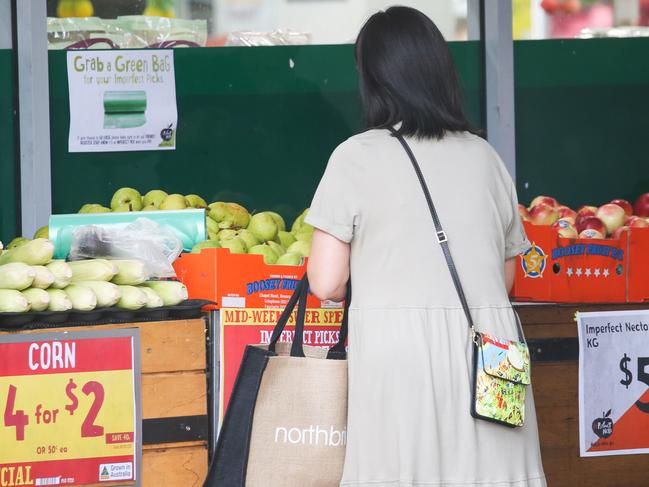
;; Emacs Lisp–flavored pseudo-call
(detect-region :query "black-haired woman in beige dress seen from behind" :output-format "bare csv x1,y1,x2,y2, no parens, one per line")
306,7,546,487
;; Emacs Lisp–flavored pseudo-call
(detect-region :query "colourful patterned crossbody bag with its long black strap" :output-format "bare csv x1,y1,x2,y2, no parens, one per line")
389,127,530,427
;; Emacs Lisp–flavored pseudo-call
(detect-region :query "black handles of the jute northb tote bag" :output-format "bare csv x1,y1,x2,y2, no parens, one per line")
268,274,351,360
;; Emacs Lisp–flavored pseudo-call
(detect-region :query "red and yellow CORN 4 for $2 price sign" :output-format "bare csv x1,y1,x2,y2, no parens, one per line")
0,329,141,487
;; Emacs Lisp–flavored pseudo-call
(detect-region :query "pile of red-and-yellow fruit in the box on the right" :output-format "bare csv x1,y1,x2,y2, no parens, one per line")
518,193,649,238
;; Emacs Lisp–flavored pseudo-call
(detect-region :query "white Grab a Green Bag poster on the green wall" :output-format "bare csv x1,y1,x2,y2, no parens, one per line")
67,49,178,152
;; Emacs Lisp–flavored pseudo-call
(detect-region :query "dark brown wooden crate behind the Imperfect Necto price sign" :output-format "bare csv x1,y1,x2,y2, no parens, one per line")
517,304,649,487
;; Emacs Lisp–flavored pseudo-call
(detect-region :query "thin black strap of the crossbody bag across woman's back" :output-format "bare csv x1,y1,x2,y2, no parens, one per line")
388,127,525,341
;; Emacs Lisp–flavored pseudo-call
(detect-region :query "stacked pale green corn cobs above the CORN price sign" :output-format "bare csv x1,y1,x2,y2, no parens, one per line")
0,238,187,313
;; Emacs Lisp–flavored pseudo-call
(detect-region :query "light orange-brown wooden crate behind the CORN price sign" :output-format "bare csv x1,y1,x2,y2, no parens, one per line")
0,319,208,487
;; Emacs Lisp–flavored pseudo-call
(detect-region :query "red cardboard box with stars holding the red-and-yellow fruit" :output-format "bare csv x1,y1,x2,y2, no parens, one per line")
512,222,649,303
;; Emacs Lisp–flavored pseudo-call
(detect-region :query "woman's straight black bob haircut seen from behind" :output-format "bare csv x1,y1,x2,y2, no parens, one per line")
355,7,471,139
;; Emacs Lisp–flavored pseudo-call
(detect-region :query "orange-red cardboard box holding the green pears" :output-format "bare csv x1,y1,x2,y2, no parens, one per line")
174,248,326,308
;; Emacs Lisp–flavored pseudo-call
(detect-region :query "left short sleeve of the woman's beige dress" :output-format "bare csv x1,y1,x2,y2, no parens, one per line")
304,143,359,243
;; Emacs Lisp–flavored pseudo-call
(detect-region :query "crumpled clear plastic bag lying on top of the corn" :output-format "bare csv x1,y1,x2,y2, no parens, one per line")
69,218,183,277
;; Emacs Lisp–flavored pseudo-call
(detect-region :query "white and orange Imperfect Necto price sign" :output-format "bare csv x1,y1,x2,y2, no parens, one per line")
577,310,649,456
